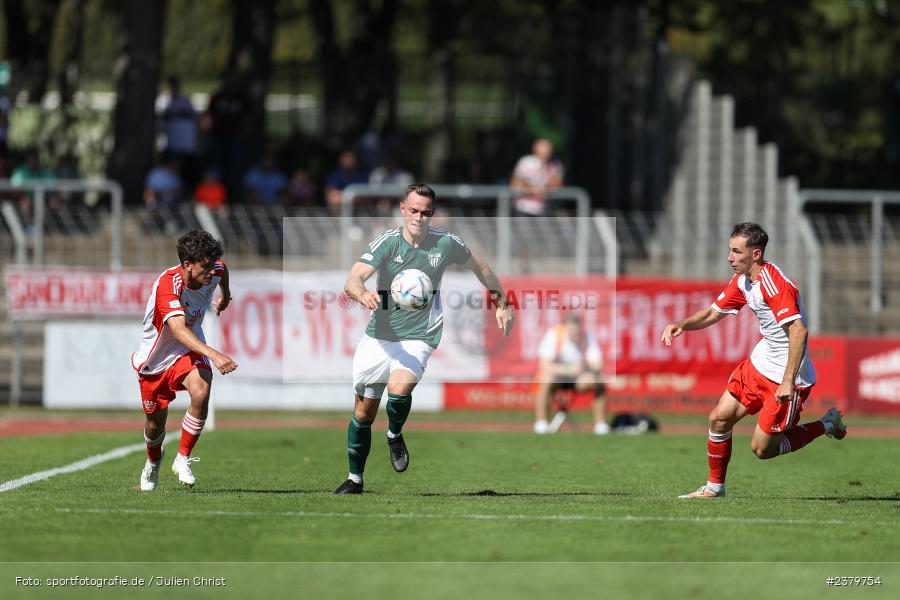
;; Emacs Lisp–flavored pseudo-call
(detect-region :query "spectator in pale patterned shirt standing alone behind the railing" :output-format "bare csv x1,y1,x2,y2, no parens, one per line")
509,138,563,216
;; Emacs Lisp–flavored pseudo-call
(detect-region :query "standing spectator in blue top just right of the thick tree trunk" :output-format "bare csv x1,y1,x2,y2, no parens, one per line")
156,75,199,190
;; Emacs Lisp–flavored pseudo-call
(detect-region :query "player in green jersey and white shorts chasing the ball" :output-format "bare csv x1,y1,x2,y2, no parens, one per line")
334,183,513,494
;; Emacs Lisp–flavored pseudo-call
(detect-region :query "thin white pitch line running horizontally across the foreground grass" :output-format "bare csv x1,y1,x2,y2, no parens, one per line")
47,508,900,527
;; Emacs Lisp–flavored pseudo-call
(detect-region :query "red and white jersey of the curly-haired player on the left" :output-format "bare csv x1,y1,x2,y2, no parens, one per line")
131,260,225,375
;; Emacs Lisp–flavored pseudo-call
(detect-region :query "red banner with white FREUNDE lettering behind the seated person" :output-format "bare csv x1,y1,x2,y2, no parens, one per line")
485,276,760,381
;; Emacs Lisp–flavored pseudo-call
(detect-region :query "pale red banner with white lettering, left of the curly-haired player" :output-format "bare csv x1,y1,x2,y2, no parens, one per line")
5,266,155,319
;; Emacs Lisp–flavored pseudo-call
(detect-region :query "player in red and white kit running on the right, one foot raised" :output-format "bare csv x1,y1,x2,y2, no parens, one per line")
662,223,847,498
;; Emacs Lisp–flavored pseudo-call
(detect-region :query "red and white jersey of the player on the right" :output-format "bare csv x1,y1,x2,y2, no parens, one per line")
712,261,816,387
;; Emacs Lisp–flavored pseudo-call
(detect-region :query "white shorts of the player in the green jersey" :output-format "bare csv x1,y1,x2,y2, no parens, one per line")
353,334,434,400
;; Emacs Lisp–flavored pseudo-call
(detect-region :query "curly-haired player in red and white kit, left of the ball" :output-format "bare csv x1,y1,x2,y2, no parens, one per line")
131,230,237,492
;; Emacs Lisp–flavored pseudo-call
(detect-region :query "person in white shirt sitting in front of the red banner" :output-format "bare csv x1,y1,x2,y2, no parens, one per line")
534,313,609,435
